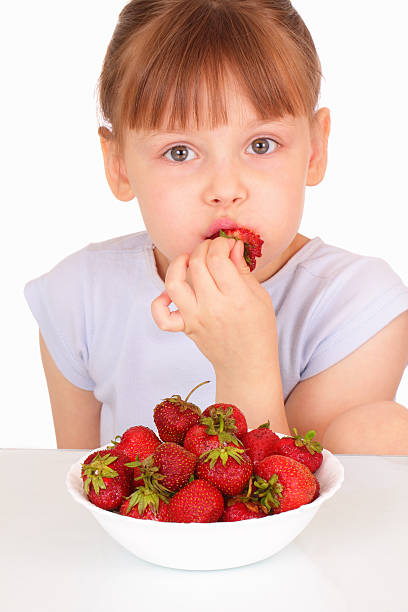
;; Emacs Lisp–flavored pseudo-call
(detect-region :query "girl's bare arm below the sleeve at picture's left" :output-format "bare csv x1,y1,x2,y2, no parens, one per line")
40,332,102,449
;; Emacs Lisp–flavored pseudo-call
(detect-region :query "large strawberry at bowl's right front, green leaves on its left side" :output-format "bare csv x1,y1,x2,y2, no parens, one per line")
254,455,316,514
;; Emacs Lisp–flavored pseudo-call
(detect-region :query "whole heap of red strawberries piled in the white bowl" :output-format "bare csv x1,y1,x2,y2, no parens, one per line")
81,381,323,523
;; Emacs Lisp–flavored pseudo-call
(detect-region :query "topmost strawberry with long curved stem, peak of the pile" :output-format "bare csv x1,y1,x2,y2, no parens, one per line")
153,380,210,444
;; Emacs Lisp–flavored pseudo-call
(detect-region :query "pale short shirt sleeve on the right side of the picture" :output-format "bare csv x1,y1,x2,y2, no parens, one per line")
300,257,408,380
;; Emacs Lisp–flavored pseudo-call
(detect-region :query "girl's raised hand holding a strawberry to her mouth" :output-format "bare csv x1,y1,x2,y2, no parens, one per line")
151,237,278,373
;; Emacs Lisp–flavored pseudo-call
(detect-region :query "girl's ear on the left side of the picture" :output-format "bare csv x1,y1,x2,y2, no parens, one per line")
98,127,135,202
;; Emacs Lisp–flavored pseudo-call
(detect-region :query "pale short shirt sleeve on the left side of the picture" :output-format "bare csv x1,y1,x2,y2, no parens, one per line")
24,249,95,391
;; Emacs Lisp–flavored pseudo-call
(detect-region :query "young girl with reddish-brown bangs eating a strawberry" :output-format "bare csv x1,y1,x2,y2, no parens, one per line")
25,0,408,454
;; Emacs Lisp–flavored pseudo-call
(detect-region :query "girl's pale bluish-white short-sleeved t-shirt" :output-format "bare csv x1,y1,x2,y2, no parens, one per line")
24,231,408,445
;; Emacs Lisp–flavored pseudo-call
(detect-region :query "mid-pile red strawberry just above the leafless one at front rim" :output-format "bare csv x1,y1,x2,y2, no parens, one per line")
153,442,197,491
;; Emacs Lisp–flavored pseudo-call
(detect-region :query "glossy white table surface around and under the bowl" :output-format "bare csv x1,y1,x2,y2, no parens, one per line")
0,449,408,612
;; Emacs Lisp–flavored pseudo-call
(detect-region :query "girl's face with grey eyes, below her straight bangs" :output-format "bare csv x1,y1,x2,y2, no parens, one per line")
110,79,330,282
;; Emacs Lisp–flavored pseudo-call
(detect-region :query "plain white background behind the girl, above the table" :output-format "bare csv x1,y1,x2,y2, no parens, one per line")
0,0,408,448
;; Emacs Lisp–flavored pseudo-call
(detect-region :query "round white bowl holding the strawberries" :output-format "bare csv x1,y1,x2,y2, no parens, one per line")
65,434,344,570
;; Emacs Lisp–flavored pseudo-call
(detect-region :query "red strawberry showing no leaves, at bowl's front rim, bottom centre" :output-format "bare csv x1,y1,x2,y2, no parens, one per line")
169,480,224,523
